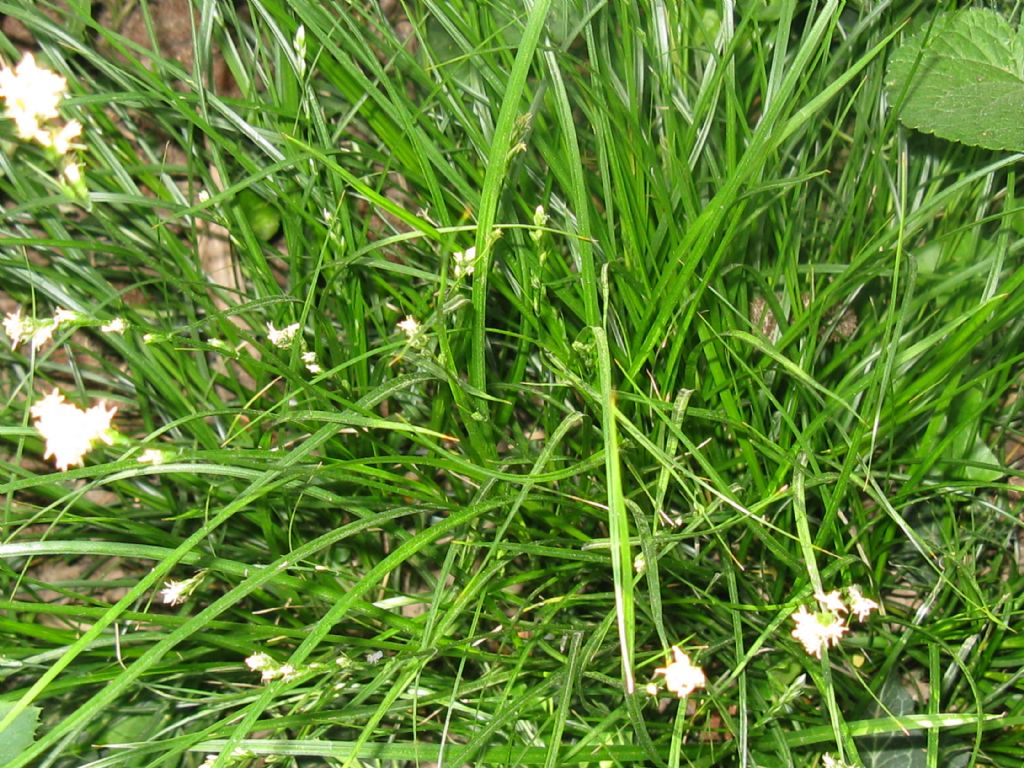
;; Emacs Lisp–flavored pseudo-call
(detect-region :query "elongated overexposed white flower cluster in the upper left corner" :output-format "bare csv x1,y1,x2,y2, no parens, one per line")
0,53,82,187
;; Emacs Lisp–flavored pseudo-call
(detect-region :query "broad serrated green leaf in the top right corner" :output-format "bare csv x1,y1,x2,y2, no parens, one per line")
886,8,1024,151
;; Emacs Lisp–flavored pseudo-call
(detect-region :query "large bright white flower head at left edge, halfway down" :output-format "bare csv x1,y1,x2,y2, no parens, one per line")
32,389,118,470
